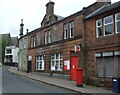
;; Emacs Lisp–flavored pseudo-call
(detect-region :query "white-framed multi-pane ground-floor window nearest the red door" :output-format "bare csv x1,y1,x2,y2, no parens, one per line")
51,53,63,71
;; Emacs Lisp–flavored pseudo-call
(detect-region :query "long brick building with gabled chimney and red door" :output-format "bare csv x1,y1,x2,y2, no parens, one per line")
28,1,109,80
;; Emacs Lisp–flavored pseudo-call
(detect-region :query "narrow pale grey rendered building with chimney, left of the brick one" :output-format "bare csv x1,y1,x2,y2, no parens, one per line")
18,19,28,72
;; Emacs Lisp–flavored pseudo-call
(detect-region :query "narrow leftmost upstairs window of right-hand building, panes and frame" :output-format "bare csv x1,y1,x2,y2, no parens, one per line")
96,19,102,38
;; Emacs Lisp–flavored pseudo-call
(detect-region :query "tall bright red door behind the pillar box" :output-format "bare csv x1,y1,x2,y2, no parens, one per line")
70,52,78,80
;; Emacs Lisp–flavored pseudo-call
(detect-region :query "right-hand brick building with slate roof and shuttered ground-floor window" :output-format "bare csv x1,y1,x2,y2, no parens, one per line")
85,2,120,88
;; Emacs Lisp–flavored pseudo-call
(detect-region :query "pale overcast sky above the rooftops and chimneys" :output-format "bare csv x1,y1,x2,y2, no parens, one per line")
0,0,119,37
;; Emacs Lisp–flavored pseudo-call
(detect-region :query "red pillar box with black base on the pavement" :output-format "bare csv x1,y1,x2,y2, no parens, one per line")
76,68,83,87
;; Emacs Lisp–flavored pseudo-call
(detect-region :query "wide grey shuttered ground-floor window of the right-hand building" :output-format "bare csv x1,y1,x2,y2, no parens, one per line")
95,52,116,78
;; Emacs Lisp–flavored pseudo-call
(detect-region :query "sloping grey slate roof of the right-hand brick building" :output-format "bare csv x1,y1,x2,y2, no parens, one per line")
86,1,120,19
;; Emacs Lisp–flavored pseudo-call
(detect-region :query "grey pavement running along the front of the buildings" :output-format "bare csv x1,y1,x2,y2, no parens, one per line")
9,67,120,95
